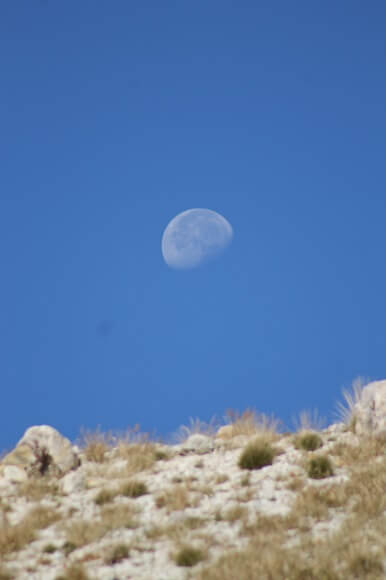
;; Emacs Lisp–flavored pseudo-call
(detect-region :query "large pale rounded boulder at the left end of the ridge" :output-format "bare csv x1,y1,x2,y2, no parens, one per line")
0,425,80,482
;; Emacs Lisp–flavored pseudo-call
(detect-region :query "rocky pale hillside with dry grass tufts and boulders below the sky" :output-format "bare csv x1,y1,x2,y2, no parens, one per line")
0,381,386,580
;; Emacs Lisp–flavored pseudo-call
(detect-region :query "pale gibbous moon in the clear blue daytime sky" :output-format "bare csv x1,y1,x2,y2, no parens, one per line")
162,209,233,270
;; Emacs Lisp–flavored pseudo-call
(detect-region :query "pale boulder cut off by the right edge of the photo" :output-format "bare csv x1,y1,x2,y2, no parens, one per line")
353,381,386,435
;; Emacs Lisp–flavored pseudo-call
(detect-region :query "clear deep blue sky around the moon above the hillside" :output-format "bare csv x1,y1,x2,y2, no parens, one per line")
0,0,386,449
